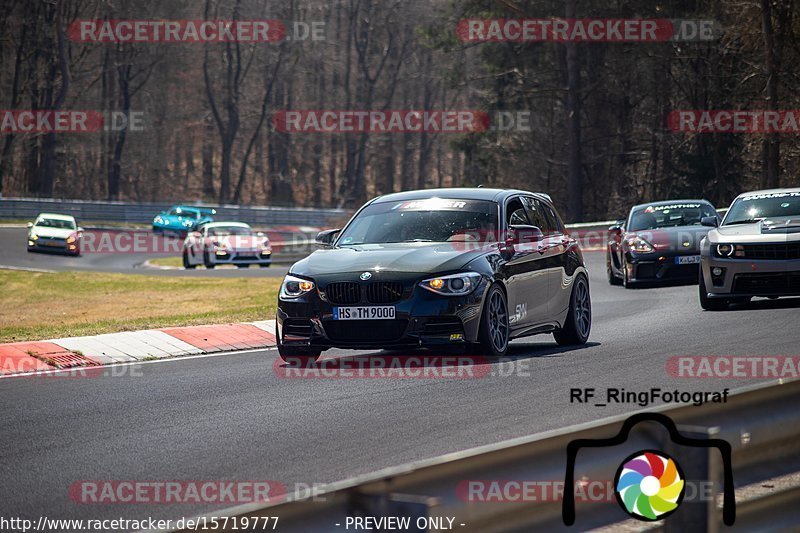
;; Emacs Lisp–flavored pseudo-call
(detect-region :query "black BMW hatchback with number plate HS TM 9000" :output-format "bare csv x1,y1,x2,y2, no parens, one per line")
277,188,592,360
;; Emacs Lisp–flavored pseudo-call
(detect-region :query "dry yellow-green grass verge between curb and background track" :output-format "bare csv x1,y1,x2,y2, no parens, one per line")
0,270,281,342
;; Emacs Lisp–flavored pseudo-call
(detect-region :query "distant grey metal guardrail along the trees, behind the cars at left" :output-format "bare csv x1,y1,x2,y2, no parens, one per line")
0,198,350,227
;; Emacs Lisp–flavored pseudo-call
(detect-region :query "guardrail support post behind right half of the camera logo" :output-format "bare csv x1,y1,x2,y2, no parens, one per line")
663,426,722,533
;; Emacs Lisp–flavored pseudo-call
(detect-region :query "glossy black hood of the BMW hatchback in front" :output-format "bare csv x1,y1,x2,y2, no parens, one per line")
290,242,497,277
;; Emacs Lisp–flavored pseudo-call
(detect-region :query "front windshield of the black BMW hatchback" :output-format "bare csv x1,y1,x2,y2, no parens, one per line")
337,198,498,246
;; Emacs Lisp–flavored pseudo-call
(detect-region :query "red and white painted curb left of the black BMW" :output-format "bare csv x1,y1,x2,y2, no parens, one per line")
0,320,275,376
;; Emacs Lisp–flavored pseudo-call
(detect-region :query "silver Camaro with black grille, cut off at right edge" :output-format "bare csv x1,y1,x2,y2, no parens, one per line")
700,188,800,311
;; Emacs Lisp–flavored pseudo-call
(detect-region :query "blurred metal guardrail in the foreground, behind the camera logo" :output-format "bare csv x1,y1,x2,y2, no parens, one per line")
169,381,800,532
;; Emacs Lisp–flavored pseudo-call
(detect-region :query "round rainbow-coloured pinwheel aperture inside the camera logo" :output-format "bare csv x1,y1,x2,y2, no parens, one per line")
614,450,685,521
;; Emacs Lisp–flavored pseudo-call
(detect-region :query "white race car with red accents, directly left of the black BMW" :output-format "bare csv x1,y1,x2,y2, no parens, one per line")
183,222,272,269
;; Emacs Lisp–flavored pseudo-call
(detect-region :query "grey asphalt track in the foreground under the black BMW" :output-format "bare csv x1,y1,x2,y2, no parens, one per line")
0,253,800,532
